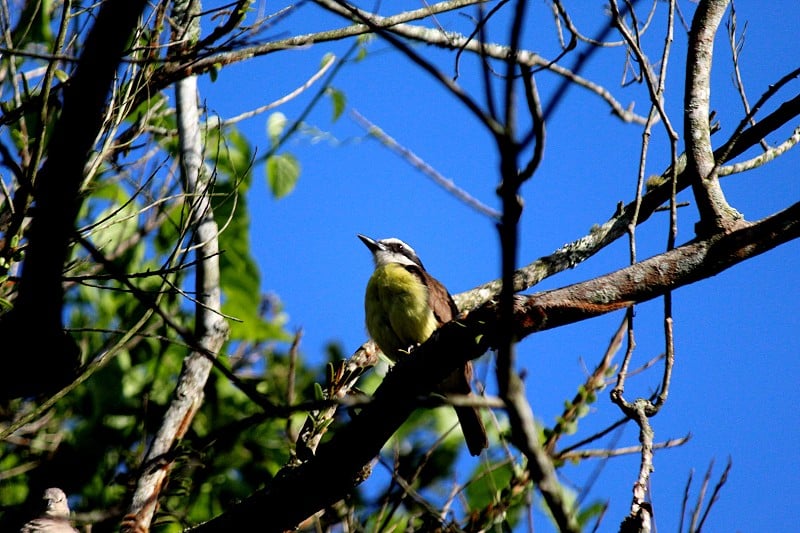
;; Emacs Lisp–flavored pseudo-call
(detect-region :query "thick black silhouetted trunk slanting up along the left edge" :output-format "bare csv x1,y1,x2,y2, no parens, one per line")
0,0,145,397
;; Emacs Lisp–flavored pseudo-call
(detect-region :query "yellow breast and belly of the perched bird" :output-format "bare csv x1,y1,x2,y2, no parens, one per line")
364,263,437,360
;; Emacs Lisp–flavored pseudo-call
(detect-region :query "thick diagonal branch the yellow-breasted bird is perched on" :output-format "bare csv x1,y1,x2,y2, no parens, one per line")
195,203,800,533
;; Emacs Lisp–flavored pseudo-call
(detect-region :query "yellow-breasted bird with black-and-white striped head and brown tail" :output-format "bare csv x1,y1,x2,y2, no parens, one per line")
358,234,489,456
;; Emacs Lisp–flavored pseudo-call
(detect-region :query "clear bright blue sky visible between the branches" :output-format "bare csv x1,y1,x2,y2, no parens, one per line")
201,0,800,532
